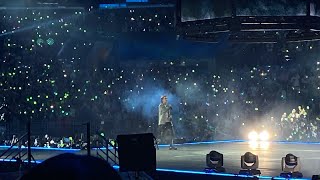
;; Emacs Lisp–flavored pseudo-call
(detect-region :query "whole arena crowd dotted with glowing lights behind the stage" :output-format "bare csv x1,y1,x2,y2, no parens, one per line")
0,5,320,148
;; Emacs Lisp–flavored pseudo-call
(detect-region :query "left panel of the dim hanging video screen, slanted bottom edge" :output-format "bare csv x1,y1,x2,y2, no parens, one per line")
181,0,232,22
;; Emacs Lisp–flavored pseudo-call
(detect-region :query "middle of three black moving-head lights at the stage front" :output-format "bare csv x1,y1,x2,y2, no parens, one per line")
239,152,261,176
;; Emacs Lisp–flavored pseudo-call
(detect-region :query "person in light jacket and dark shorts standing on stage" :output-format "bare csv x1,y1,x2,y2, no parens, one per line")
158,96,177,150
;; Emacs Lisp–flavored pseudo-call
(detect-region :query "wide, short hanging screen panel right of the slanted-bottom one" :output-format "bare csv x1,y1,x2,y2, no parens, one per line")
235,0,307,16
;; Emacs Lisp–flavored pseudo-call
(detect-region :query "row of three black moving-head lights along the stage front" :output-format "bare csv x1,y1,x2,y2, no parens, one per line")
205,151,302,179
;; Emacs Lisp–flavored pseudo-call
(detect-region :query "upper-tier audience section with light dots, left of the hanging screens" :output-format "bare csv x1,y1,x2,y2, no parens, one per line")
89,7,175,33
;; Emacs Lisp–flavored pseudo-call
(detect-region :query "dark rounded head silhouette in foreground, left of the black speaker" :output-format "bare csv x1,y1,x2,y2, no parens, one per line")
21,153,121,180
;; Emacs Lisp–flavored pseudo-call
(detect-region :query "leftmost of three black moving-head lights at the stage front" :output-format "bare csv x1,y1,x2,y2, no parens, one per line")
205,151,226,172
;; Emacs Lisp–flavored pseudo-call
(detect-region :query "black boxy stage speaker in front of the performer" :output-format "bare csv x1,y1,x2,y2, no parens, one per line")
117,133,156,172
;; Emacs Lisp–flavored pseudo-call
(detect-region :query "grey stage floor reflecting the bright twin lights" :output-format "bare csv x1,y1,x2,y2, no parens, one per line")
0,141,320,178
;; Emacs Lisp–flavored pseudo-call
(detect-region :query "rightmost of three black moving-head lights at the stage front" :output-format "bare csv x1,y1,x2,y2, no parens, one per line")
280,154,303,178
